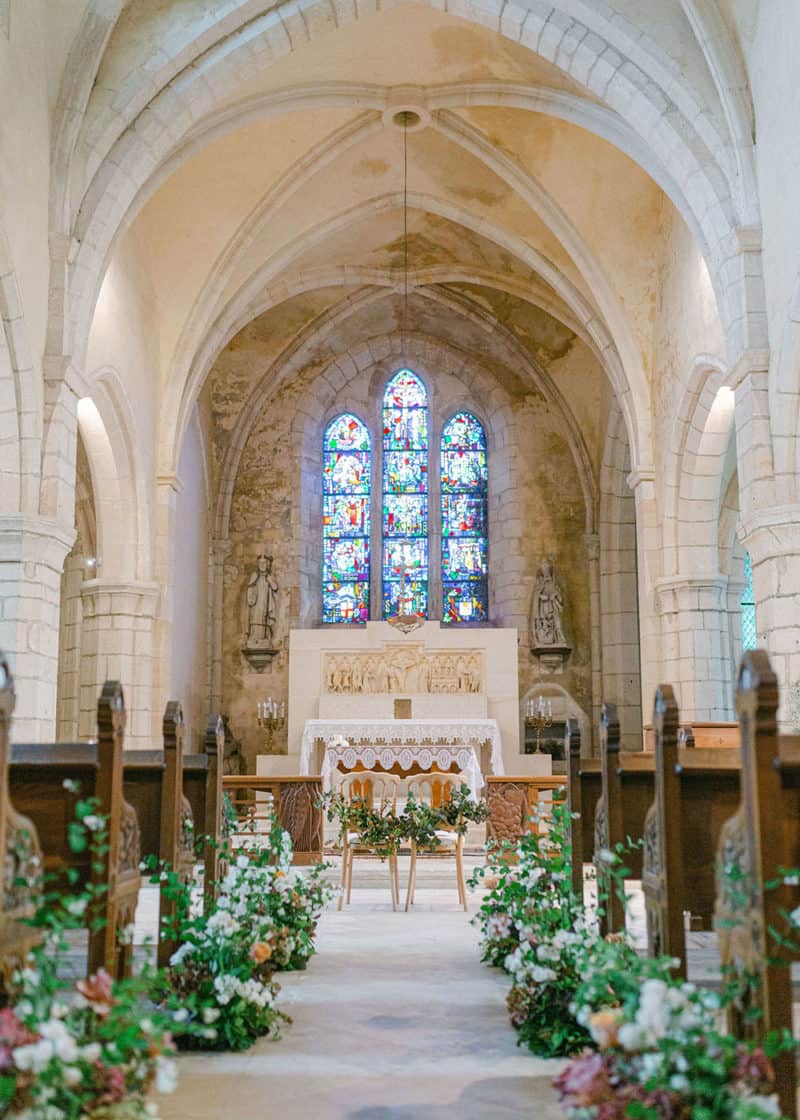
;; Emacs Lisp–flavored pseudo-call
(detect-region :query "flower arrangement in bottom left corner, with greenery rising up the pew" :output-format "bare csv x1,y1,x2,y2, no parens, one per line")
0,800,176,1120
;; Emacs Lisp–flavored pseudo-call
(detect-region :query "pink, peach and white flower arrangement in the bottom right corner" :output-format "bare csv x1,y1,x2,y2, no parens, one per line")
556,977,791,1120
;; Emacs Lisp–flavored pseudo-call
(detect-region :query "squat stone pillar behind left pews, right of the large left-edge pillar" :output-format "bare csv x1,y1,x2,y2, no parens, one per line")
78,578,161,749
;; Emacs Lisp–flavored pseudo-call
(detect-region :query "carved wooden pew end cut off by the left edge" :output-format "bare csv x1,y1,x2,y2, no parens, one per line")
0,654,41,999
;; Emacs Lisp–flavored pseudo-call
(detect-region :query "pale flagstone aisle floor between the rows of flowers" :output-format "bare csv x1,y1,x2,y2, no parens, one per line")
159,860,562,1120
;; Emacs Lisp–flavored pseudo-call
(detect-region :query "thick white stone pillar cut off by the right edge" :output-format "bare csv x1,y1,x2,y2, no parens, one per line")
739,505,800,730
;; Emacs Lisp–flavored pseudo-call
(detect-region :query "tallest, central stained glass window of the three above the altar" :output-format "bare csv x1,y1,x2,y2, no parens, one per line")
382,370,428,618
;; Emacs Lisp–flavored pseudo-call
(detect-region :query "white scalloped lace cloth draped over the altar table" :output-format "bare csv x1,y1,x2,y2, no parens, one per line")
300,719,503,800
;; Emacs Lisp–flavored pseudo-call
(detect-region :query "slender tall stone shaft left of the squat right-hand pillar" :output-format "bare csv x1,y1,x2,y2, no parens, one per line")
627,469,662,734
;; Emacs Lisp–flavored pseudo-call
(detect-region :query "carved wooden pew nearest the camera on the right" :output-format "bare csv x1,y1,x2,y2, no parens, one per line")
716,650,800,1117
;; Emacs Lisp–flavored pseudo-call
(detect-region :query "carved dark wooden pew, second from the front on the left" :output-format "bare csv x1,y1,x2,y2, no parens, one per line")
9,681,141,977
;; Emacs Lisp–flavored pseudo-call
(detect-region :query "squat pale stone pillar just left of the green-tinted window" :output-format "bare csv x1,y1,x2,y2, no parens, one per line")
655,572,733,721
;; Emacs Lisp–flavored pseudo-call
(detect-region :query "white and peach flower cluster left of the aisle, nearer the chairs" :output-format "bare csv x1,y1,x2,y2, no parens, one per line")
156,822,335,1051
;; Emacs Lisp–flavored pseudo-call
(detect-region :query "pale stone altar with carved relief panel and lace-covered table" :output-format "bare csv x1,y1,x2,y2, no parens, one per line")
257,620,549,787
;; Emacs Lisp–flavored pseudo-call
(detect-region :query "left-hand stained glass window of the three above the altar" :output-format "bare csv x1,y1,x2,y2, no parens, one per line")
323,412,371,623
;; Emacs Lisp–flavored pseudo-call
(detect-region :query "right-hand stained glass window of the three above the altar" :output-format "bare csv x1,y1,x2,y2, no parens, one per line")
441,412,489,623
